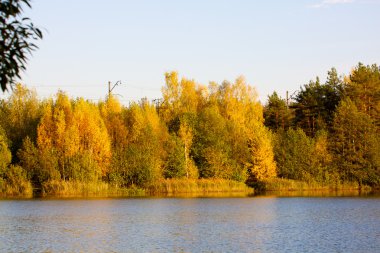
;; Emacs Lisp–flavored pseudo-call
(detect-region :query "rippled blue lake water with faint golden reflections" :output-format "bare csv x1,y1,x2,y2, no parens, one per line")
0,196,380,252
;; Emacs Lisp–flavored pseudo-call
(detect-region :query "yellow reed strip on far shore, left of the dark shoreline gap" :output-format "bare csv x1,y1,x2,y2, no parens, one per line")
0,179,254,198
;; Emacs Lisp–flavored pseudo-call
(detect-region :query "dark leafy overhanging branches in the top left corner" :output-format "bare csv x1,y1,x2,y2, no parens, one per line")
0,0,42,91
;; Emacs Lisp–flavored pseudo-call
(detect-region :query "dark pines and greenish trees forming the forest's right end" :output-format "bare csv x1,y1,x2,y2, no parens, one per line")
264,63,380,187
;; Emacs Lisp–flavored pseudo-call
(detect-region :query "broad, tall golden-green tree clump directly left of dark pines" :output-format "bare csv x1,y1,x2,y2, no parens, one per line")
195,77,276,181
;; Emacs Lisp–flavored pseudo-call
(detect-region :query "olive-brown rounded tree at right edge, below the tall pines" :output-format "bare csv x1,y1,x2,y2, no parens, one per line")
331,99,380,185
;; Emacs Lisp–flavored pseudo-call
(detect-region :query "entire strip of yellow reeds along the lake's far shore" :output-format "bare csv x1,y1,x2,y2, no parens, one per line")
0,178,376,198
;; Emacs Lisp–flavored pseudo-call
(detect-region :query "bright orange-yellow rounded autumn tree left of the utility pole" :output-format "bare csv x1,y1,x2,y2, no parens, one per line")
32,92,111,181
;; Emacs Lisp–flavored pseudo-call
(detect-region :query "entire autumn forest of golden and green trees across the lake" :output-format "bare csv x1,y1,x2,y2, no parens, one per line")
0,63,380,195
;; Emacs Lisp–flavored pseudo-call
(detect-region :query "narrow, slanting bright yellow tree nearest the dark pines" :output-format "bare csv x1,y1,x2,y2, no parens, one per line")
225,77,276,180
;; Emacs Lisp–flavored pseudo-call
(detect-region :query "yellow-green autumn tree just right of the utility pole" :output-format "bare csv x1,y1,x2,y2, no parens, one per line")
111,102,167,187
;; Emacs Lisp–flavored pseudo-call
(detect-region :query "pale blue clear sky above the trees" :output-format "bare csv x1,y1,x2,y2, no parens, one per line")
2,0,380,104
